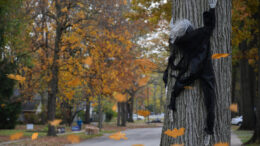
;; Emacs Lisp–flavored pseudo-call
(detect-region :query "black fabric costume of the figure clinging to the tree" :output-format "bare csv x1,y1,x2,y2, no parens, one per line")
163,8,215,134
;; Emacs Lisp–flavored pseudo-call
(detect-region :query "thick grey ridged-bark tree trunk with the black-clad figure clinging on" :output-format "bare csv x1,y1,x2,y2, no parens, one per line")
160,0,232,146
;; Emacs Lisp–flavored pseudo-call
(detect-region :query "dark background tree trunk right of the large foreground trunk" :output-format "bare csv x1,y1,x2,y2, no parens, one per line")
240,50,255,130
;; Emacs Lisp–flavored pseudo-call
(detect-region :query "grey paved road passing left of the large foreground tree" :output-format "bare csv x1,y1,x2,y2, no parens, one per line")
70,128,162,146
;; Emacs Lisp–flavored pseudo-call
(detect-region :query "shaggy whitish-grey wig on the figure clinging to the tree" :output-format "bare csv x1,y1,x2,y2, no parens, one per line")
170,19,193,44
